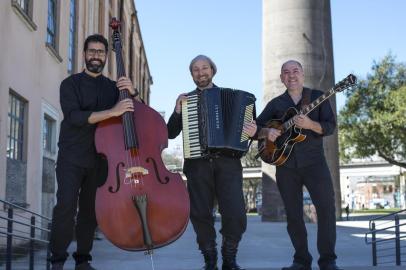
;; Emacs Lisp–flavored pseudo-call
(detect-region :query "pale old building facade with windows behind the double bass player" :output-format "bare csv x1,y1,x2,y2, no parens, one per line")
0,0,152,221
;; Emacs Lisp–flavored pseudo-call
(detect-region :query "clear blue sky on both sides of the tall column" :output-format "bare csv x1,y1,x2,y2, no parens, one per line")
135,0,406,151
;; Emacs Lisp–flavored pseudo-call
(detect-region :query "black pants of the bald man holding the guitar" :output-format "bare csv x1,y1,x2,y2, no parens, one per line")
276,161,337,266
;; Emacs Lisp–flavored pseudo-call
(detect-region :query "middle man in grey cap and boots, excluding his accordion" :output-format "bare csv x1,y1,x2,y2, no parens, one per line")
167,55,247,270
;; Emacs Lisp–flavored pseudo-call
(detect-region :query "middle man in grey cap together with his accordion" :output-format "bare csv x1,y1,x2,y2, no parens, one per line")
167,55,255,270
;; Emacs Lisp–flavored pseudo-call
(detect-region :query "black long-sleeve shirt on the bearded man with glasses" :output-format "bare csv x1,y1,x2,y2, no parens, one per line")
58,72,119,168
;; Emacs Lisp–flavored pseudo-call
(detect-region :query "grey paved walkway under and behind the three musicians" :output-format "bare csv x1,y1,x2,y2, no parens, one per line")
9,216,406,270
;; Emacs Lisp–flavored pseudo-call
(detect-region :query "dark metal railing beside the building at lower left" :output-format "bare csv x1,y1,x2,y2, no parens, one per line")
0,199,51,270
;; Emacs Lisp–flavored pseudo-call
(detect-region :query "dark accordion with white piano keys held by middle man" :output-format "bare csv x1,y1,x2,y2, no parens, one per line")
182,87,256,159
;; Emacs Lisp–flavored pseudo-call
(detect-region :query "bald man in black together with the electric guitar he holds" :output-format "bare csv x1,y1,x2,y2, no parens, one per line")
244,60,355,270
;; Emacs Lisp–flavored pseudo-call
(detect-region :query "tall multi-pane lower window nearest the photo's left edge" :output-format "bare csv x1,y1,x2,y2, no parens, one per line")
7,93,27,161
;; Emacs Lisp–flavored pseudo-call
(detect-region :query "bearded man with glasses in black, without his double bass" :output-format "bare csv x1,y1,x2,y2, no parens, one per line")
50,34,136,270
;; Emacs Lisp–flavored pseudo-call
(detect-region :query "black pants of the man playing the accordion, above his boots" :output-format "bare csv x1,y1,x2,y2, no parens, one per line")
184,157,247,247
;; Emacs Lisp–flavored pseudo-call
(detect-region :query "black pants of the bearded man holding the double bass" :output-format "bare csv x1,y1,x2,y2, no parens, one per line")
50,159,97,262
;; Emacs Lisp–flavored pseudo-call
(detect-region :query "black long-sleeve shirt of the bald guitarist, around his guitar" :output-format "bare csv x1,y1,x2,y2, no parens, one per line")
256,87,336,168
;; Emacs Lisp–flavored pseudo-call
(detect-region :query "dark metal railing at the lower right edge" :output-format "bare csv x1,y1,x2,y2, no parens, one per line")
365,209,406,266
